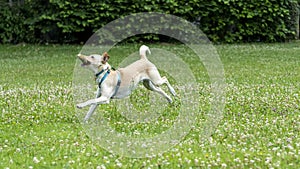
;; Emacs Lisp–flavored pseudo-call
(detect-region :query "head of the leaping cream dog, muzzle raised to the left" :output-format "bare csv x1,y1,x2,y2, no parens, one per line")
77,52,110,73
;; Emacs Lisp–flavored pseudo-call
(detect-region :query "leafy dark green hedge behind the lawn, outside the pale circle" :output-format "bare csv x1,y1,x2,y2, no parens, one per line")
0,0,300,43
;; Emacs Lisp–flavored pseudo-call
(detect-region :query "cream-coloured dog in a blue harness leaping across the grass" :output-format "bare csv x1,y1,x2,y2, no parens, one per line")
77,45,176,121
